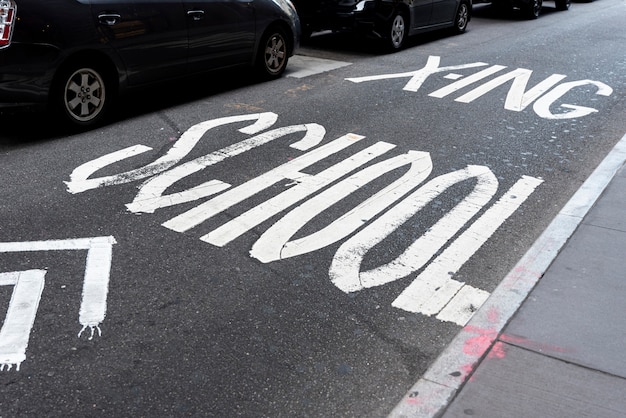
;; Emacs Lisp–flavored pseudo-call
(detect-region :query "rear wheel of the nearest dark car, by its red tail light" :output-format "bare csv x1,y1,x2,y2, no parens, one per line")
52,64,114,128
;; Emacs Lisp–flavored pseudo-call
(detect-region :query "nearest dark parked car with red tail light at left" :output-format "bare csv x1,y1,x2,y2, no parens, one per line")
0,0,300,127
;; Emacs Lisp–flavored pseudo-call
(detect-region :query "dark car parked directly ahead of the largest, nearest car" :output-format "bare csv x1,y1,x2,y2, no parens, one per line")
293,0,472,50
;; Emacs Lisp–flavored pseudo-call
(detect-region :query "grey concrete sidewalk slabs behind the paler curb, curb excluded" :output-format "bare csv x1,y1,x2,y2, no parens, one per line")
443,162,626,418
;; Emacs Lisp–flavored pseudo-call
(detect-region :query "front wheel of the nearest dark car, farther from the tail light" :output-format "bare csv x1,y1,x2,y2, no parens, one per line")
257,27,289,79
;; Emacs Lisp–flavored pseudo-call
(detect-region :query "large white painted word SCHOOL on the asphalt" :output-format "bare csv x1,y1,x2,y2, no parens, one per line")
67,112,541,325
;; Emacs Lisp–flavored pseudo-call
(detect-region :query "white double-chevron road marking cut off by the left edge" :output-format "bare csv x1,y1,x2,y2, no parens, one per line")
0,236,116,370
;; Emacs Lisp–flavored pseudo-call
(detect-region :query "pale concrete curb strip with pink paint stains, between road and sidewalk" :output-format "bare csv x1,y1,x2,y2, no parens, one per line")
388,131,626,418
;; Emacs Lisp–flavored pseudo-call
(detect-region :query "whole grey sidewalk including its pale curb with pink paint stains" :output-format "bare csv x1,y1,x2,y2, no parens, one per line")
390,136,626,418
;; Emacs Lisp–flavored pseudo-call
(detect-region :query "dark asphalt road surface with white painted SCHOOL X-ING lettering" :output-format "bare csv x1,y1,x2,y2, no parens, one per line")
0,0,626,417
